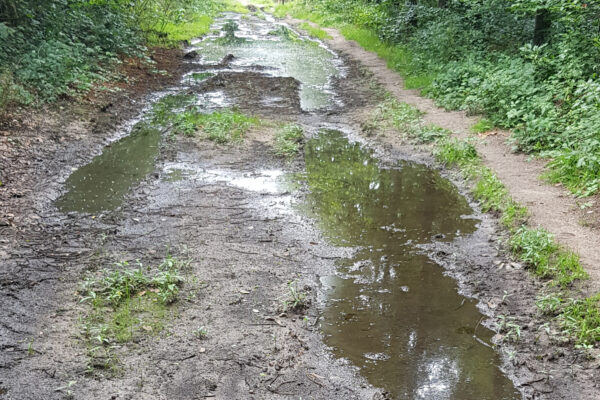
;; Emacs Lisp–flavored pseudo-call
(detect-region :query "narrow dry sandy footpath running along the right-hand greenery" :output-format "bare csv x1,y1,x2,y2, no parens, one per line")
289,19,600,293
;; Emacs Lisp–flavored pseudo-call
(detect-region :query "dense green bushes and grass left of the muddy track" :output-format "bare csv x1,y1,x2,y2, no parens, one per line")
0,0,218,105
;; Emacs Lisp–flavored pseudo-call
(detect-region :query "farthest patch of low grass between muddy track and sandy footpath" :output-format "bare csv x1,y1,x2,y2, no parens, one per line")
366,94,450,143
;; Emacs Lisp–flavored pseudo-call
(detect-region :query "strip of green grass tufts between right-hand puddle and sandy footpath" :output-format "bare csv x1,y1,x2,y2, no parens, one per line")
376,96,600,349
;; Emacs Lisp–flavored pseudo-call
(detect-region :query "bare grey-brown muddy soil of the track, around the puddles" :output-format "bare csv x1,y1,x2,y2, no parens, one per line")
0,17,599,399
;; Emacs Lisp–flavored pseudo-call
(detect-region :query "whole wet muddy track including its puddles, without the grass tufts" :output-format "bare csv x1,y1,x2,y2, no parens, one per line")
0,8,596,399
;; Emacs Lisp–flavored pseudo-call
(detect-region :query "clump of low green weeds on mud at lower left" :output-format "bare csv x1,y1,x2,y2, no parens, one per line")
79,255,188,374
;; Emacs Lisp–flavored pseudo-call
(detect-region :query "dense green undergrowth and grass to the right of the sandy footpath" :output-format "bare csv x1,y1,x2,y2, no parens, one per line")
285,0,600,195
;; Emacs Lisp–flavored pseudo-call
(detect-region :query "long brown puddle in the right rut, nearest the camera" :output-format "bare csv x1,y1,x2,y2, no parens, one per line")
304,131,520,400
